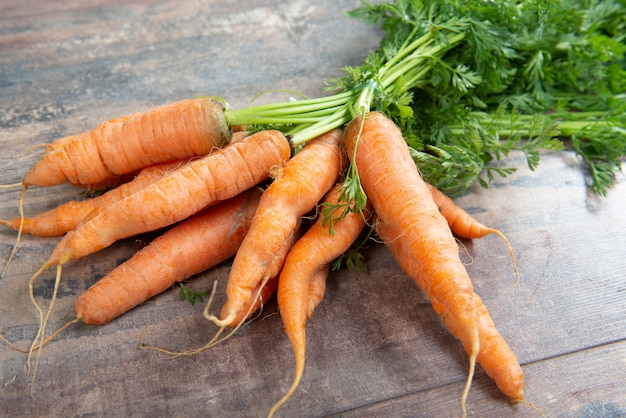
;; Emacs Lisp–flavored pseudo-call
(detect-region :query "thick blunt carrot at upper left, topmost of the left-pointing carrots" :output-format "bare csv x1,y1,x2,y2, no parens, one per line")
23,98,230,187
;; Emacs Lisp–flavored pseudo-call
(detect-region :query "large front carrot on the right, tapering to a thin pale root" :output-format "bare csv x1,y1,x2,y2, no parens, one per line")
345,112,480,416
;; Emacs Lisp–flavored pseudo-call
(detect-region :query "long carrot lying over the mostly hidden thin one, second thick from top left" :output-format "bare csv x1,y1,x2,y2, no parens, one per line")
44,130,291,266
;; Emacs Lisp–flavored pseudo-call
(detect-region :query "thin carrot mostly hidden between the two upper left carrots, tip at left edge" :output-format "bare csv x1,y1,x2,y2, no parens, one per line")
0,161,189,237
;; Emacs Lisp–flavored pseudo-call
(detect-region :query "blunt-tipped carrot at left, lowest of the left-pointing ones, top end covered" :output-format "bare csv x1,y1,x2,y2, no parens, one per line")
76,188,261,325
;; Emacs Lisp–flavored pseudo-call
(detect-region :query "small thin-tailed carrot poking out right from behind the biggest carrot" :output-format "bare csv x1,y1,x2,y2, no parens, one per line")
426,183,520,282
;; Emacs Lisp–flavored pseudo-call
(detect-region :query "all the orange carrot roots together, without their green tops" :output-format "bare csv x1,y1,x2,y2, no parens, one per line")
3,98,523,413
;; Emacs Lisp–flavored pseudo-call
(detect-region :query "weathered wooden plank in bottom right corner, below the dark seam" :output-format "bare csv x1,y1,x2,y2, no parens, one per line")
330,341,626,418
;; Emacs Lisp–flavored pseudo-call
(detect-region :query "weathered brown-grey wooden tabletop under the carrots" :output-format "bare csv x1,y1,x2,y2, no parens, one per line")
0,0,626,417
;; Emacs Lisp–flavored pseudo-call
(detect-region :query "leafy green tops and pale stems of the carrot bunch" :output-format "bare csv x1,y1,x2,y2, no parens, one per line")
226,0,626,202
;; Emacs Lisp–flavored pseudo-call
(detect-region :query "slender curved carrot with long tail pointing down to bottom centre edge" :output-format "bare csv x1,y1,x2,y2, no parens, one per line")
269,185,366,416
